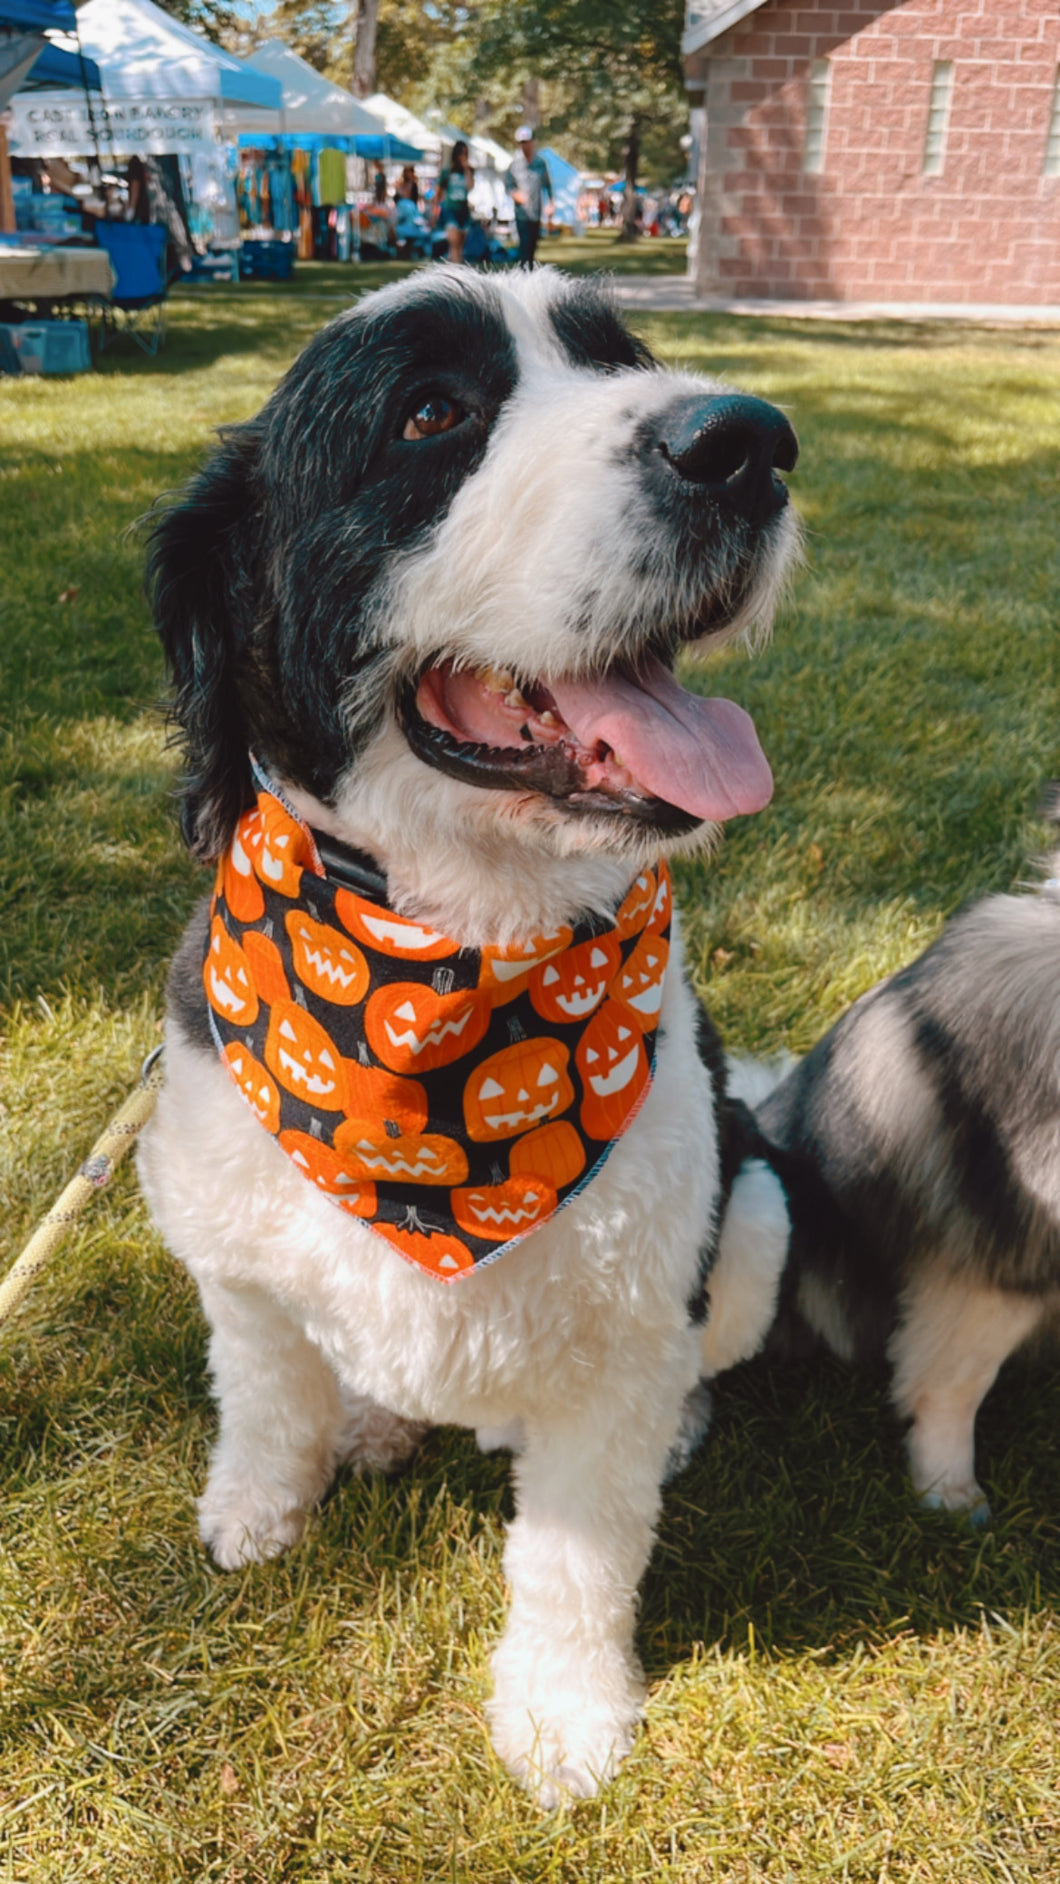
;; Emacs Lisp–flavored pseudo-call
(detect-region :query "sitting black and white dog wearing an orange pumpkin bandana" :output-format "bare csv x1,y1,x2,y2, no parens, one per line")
139,268,798,1801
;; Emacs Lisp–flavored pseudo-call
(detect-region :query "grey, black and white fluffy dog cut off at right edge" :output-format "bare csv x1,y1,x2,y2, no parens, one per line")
730,821,1060,1522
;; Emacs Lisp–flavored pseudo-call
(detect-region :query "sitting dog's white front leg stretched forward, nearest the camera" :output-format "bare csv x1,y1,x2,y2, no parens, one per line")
488,1353,697,1807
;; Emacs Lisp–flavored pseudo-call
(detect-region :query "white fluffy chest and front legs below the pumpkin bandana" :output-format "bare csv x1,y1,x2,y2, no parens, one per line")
139,934,717,1803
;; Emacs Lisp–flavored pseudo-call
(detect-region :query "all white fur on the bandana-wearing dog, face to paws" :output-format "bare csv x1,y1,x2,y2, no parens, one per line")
139,271,795,1803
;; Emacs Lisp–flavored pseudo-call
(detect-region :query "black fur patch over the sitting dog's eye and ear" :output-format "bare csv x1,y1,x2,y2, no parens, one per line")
147,283,516,857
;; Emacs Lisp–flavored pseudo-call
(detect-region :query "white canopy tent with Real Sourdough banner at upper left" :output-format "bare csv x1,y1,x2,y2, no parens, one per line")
9,0,282,164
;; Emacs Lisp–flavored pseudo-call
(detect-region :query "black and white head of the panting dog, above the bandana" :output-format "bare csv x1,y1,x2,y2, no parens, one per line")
151,268,796,934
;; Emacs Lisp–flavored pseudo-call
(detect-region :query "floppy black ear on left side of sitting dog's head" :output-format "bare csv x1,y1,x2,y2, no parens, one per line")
145,422,258,861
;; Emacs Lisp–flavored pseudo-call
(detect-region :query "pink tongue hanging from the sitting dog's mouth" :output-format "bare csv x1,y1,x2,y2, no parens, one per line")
552,661,774,821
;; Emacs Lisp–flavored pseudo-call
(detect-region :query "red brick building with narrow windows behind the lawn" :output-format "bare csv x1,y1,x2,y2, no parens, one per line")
683,0,1060,305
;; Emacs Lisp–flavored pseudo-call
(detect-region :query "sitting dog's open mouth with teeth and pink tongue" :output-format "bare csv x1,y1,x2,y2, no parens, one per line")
399,656,772,831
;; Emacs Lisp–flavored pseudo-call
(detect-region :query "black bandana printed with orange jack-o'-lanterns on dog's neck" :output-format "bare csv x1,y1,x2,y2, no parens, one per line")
203,772,670,1281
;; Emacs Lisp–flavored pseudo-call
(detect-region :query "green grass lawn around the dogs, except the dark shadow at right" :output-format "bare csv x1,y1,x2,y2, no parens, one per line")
0,269,1060,1884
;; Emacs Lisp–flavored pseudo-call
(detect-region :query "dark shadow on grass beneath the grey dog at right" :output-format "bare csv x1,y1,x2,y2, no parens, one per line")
638,1360,1060,1679
